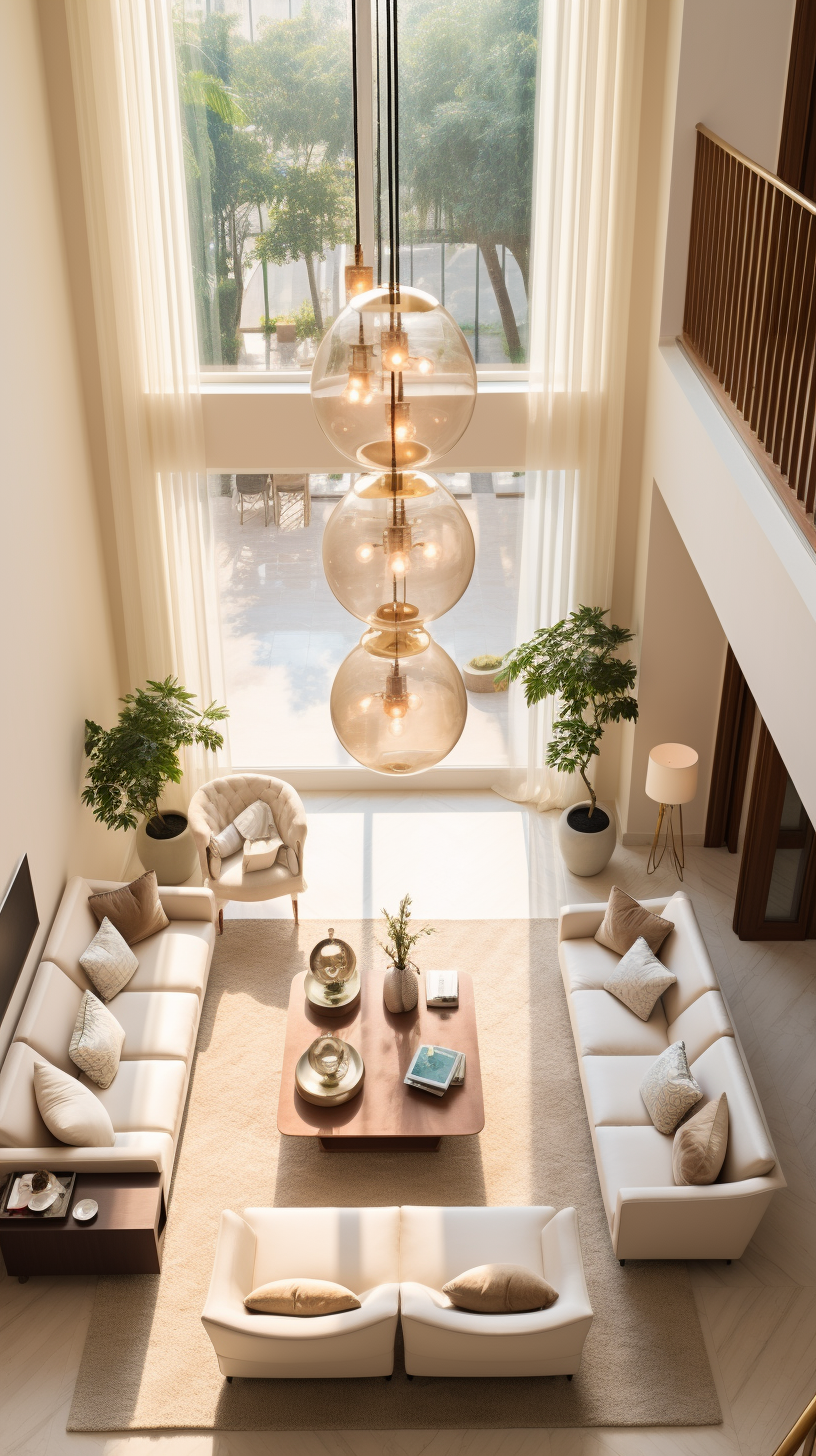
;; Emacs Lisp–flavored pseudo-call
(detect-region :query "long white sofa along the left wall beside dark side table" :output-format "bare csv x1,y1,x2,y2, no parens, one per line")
0,877,216,1190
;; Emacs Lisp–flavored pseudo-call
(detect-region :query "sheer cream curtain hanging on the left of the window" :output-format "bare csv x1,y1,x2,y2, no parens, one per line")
66,0,227,796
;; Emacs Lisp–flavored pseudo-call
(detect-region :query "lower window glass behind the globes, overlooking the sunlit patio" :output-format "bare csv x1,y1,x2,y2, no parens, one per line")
210,470,523,769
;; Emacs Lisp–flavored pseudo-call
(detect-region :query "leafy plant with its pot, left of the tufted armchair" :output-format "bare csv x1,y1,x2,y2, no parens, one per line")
82,677,229,885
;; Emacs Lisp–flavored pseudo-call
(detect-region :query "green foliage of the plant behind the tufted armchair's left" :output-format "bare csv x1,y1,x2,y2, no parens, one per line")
82,677,229,828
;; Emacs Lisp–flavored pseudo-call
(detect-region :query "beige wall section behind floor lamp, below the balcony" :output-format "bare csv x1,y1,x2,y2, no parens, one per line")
624,486,727,844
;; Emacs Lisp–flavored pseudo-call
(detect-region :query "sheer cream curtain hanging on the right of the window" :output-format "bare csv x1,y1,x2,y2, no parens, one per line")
497,0,646,808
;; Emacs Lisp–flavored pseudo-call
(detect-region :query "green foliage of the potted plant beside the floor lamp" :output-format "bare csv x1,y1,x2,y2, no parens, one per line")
498,607,638,818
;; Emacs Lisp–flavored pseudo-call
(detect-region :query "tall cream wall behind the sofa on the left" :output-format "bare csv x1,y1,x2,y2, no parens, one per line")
0,0,127,1056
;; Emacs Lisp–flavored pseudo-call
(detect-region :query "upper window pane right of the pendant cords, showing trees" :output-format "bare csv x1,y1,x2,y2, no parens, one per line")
393,0,539,367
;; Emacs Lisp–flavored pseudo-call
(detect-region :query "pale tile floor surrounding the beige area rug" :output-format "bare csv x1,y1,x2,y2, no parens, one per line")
0,792,816,1456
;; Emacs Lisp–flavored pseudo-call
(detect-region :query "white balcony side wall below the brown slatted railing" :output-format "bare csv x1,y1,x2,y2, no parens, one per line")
644,337,816,823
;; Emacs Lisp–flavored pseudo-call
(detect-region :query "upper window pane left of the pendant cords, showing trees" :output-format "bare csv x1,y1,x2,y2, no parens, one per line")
176,0,354,370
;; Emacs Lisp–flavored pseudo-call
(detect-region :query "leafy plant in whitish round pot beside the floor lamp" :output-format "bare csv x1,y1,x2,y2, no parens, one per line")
500,607,638,875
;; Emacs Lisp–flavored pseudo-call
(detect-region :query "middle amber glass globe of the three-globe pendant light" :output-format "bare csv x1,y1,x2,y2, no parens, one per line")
323,470,475,626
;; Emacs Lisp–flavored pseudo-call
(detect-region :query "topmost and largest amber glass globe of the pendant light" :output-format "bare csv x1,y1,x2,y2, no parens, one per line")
312,288,476,470
